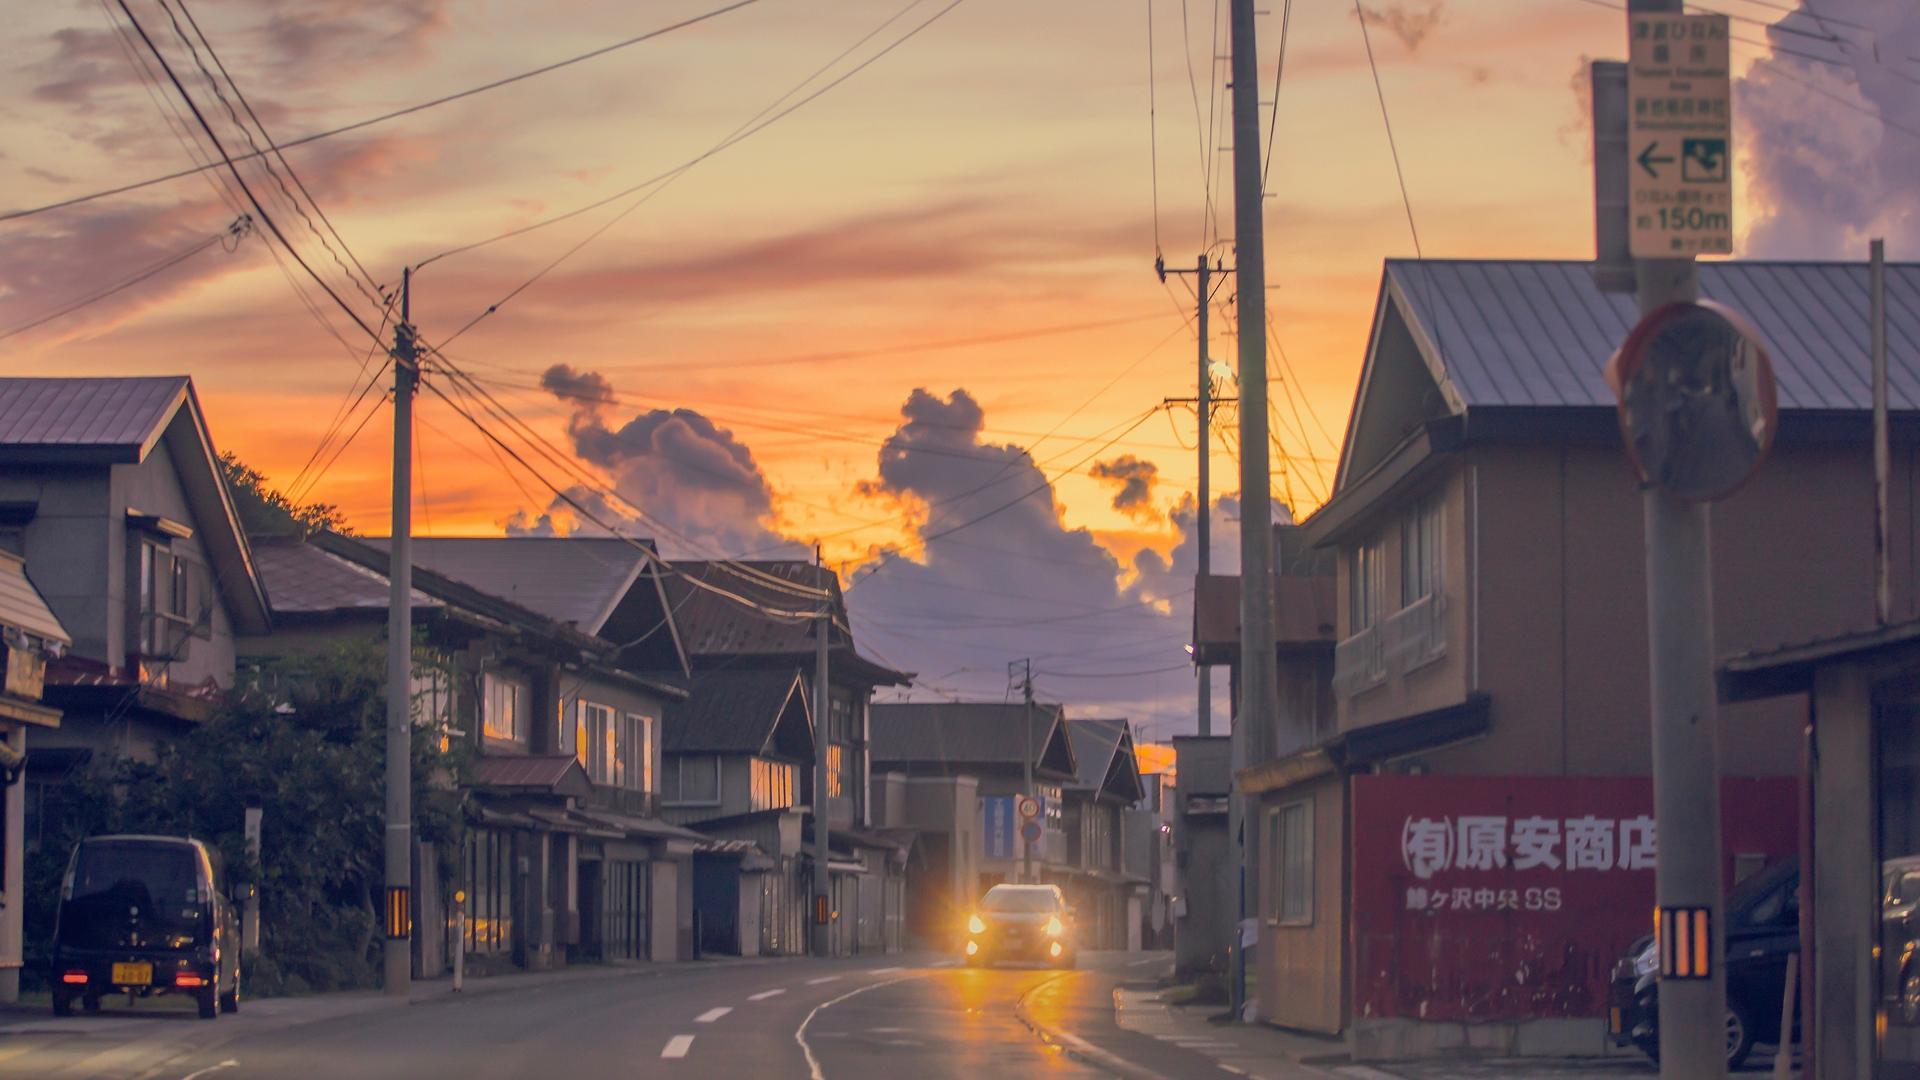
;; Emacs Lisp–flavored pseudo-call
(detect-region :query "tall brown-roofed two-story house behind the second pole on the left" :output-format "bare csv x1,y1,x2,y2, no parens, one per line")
660,559,912,955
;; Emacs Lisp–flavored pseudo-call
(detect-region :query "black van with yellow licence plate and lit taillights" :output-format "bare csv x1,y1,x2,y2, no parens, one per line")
50,836,240,1020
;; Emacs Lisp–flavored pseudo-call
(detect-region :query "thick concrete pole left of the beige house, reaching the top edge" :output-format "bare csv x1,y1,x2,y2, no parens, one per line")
1227,0,1279,1019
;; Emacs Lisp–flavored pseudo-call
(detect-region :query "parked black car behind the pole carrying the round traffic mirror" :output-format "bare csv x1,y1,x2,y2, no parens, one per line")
1607,859,1799,1068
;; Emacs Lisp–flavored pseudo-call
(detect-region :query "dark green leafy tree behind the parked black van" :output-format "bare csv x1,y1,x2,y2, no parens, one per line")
29,638,467,992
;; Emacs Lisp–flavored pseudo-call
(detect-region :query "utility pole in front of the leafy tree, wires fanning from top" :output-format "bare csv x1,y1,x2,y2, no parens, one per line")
384,269,420,999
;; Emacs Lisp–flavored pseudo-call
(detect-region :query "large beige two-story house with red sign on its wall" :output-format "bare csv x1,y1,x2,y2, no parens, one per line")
1240,259,1920,1055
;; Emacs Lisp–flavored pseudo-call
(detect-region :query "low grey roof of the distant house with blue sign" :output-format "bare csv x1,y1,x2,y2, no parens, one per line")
868,701,1079,780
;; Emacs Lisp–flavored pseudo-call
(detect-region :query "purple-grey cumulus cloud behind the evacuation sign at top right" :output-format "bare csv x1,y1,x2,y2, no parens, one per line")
1734,0,1920,259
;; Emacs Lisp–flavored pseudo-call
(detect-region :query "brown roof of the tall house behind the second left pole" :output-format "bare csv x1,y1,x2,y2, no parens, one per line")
660,559,912,686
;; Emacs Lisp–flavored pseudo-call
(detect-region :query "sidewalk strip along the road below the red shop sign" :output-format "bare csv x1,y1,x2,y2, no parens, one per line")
1114,990,1666,1080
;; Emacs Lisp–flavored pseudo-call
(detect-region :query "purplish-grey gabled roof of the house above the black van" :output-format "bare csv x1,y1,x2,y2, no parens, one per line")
0,375,271,634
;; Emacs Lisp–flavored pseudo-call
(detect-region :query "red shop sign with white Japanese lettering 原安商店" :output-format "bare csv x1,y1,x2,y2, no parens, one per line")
1352,776,1797,1020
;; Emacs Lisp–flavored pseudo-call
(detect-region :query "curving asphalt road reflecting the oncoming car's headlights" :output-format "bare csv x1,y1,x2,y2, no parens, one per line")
0,953,1290,1080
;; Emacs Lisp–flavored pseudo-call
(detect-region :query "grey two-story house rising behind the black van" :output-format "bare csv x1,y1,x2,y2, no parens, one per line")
0,375,269,844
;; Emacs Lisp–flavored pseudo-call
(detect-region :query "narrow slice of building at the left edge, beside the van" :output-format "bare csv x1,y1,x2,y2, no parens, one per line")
0,552,73,1001
